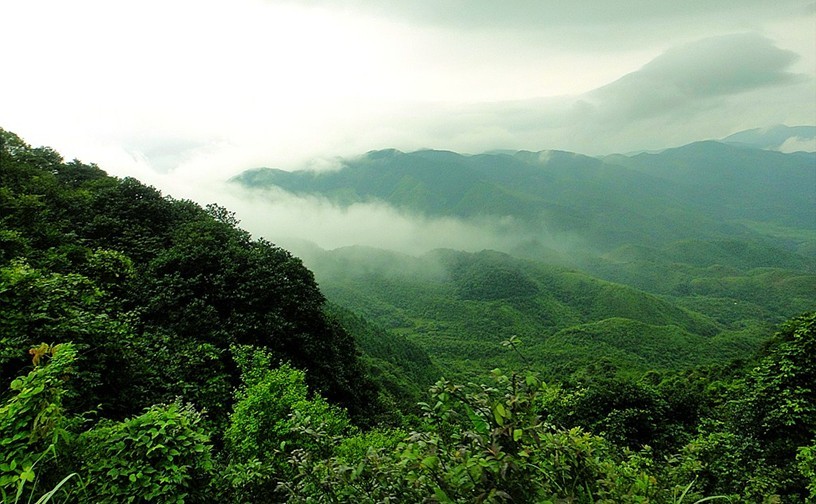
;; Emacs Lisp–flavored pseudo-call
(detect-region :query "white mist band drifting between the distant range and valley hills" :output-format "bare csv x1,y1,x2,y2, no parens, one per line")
173,184,575,255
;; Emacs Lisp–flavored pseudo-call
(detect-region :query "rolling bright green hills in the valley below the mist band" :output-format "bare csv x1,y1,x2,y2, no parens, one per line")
288,247,792,379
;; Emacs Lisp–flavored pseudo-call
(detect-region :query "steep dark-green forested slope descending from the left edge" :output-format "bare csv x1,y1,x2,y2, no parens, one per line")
0,129,427,423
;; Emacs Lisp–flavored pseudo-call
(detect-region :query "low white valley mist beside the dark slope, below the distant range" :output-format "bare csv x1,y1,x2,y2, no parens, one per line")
181,183,592,276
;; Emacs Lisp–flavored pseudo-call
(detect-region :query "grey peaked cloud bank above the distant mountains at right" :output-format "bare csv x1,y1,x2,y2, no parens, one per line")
400,33,816,154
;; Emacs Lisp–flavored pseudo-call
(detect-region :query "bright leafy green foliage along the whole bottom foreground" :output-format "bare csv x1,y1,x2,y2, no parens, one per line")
0,313,816,503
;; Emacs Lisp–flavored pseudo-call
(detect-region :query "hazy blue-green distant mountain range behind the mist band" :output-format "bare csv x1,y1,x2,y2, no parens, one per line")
232,134,816,253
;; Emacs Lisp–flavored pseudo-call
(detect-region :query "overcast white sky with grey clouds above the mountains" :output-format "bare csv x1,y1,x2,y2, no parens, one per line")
0,0,816,192
